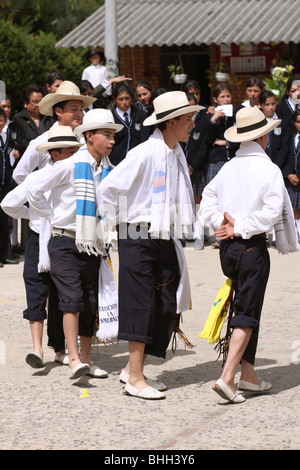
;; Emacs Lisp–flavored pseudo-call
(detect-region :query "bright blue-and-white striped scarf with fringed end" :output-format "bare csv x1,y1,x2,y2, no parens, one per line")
74,147,113,256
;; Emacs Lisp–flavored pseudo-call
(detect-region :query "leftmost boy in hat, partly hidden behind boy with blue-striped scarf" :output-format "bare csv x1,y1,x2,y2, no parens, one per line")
1,126,81,368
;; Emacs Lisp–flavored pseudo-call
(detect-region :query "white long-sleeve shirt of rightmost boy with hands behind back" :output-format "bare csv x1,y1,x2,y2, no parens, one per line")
198,142,285,239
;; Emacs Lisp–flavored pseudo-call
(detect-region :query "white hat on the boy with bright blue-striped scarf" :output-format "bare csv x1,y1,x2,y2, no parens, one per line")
74,108,124,137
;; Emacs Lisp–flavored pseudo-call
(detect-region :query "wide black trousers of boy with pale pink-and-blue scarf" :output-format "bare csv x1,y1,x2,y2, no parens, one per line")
118,225,179,358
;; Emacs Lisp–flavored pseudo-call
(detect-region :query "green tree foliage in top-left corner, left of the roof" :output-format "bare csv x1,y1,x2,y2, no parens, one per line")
0,0,104,113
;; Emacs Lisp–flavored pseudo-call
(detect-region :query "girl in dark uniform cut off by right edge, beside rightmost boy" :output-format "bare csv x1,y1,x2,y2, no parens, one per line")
283,109,300,237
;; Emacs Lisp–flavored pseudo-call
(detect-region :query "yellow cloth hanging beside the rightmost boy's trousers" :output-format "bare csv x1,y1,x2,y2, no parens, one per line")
199,279,232,344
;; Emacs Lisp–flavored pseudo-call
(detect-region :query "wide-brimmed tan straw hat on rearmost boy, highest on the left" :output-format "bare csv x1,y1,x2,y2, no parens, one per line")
39,80,96,116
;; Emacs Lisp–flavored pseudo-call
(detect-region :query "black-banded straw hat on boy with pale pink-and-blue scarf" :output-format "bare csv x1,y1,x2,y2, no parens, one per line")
143,91,204,126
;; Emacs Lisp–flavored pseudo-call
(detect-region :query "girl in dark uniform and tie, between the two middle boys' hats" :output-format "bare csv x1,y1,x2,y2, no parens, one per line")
109,83,149,166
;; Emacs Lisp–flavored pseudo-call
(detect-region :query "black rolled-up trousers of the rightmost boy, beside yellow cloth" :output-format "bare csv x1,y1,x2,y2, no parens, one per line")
220,235,270,364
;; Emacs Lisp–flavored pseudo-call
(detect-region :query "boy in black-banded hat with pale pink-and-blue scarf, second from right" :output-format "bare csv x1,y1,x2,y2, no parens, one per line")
97,91,202,399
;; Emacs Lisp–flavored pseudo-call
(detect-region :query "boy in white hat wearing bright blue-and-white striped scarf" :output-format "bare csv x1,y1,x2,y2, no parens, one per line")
27,109,123,379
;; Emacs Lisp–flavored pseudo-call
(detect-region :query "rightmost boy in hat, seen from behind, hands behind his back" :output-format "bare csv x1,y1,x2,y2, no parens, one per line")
199,106,299,403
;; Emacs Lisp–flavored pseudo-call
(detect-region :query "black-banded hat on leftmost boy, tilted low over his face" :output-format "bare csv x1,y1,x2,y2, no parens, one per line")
36,126,82,153
